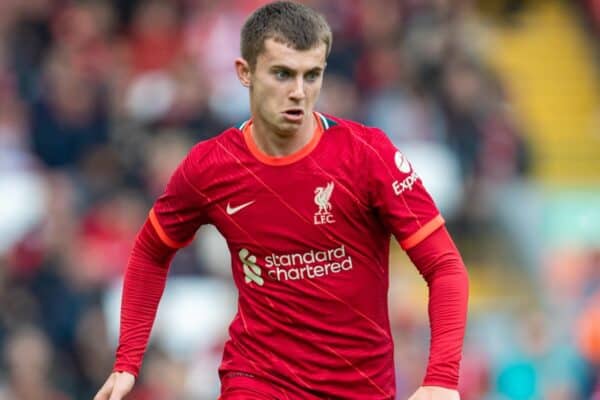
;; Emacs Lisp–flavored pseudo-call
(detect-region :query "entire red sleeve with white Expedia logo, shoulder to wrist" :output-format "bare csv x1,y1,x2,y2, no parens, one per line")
356,128,469,389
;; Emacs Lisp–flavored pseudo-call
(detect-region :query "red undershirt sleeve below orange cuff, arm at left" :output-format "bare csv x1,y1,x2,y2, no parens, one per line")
113,220,176,377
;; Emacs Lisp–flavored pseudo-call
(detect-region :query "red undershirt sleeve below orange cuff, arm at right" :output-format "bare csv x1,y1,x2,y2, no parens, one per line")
407,226,469,389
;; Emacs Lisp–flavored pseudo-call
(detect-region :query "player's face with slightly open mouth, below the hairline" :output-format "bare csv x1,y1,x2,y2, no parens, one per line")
243,39,326,136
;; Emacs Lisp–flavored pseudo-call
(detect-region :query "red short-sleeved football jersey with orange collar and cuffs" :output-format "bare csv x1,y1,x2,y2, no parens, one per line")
117,113,464,399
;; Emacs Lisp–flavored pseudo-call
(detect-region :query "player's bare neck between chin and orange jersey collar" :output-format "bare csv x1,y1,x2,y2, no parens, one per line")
250,113,317,157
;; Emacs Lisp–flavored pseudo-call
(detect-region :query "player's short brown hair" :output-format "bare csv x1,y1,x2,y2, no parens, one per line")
240,1,333,68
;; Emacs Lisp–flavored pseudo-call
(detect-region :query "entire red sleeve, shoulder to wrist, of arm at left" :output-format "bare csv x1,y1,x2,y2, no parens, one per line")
114,144,210,376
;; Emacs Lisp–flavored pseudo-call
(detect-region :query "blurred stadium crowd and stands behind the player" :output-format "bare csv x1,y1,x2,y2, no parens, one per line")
0,0,600,400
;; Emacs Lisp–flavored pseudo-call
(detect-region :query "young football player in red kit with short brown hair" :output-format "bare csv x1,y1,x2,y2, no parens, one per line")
96,2,468,400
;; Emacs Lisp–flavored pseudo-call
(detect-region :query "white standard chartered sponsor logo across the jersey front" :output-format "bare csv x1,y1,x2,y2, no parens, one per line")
239,245,353,286
